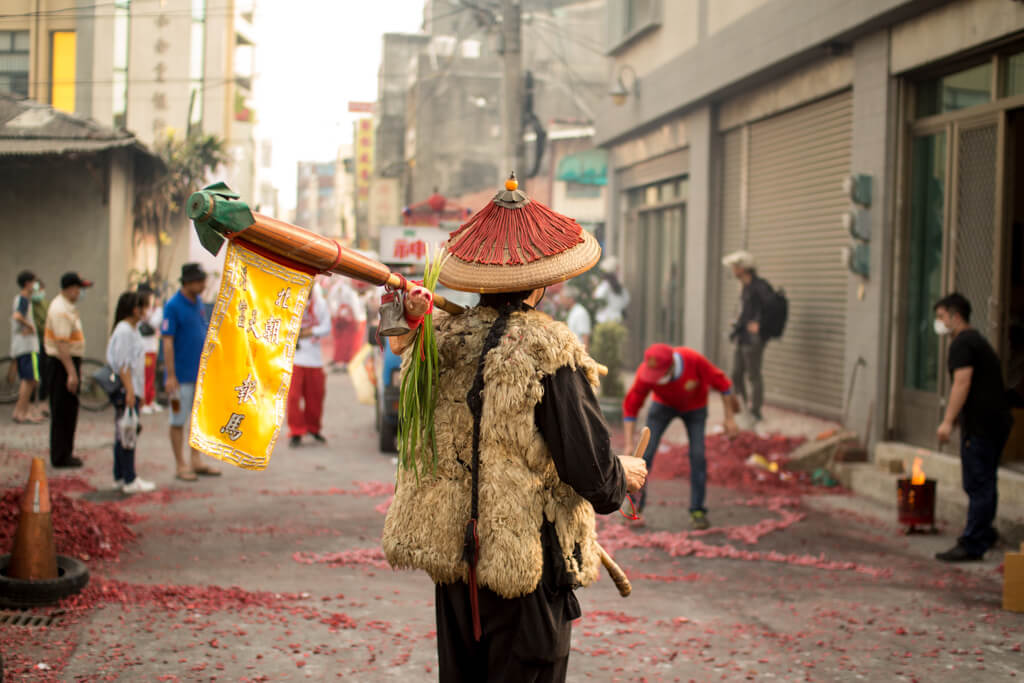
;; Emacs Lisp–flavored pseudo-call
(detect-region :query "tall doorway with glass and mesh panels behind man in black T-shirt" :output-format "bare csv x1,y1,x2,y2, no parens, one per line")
895,112,1009,449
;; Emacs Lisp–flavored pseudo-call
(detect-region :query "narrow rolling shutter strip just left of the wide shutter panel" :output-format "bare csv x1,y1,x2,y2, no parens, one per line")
715,128,746,371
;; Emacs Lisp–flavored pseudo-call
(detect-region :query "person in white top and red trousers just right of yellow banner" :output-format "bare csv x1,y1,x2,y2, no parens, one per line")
288,285,331,447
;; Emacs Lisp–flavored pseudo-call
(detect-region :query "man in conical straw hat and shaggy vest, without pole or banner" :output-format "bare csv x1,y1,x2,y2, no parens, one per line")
383,179,646,682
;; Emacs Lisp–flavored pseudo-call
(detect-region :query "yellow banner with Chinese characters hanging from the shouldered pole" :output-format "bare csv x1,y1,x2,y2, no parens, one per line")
188,243,313,470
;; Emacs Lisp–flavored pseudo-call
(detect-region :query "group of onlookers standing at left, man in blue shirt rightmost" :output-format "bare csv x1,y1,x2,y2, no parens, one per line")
11,263,220,494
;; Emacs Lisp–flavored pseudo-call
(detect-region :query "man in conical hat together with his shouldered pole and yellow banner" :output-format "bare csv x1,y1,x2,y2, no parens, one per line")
188,179,646,682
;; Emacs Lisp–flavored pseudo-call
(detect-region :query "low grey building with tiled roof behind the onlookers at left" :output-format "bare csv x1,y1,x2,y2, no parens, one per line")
0,94,163,357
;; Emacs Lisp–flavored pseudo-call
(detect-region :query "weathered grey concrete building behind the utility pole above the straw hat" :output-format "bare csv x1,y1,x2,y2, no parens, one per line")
397,0,606,204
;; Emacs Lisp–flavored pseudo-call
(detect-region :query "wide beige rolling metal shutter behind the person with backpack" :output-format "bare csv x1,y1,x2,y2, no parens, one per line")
746,91,853,417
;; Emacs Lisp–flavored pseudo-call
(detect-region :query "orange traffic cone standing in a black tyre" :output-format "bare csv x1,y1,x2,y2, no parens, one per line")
6,458,57,581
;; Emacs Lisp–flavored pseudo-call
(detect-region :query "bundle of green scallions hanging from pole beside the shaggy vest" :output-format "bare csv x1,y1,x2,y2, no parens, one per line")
398,248,445,480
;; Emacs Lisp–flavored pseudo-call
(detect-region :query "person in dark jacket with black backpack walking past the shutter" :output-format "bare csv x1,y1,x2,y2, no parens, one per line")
722,251,787,423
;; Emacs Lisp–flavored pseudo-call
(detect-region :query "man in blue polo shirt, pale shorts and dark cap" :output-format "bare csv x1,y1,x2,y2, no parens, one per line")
161,263,220,481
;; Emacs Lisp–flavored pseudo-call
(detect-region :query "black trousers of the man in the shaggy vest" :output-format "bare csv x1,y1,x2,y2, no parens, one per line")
434,583,580,683
